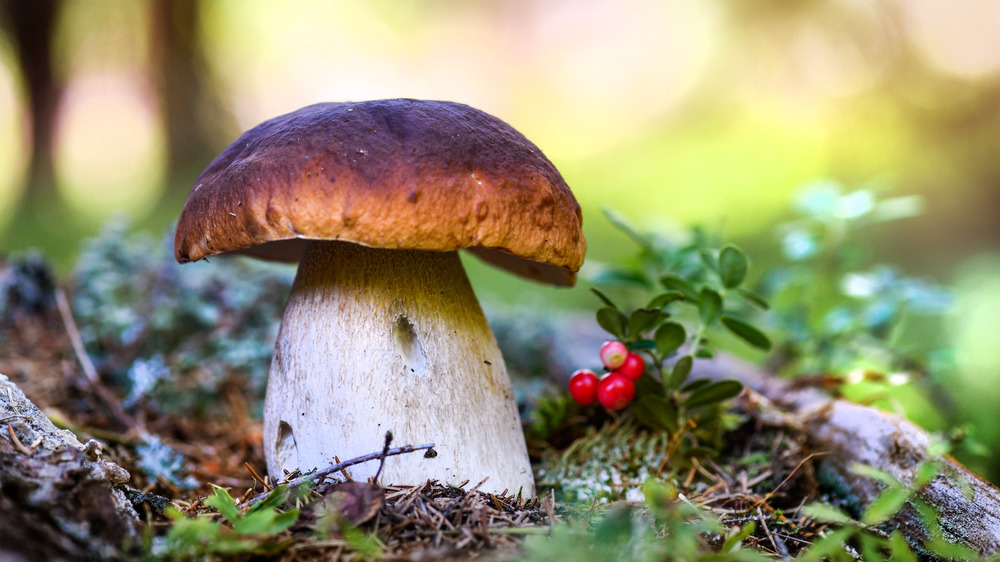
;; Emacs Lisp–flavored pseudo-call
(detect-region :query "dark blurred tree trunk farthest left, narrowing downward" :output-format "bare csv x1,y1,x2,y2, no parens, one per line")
0,0,63,201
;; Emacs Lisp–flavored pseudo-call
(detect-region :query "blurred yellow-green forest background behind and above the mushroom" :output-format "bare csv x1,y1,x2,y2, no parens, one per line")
0,0,1000,472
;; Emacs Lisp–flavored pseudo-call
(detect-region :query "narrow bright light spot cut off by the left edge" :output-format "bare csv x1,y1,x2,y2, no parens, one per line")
0,41,29,230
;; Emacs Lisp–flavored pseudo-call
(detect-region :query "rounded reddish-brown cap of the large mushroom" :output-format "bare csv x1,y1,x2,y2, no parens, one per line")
174,99,586,285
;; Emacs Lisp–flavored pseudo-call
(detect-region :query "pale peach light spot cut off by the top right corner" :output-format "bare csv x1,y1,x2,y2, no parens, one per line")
898,0,1000,77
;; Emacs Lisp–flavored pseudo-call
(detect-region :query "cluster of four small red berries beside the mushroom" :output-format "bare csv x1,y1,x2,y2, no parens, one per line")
569,340,646,410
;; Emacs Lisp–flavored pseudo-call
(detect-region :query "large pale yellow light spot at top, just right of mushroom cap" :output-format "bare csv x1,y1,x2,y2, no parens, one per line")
509,0,721,159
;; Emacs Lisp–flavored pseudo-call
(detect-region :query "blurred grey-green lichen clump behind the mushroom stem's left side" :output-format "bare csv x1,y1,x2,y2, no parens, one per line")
72,223,294,412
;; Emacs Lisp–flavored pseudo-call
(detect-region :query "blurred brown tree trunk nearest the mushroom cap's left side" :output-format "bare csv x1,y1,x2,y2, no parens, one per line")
150,0,232,189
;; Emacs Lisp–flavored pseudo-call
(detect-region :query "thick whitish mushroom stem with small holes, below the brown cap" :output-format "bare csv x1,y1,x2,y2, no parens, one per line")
264,238,535,495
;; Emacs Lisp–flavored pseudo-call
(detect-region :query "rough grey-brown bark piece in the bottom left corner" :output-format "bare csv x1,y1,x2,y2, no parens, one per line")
0,374,138,560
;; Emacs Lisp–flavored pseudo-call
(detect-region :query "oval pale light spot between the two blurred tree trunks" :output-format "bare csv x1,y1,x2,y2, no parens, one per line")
55,74,165,222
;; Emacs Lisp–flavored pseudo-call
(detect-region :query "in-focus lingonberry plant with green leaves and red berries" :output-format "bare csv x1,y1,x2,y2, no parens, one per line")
571,208,771,433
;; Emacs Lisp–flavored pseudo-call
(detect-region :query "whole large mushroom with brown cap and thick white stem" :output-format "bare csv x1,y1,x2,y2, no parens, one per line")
174,99,586,494
